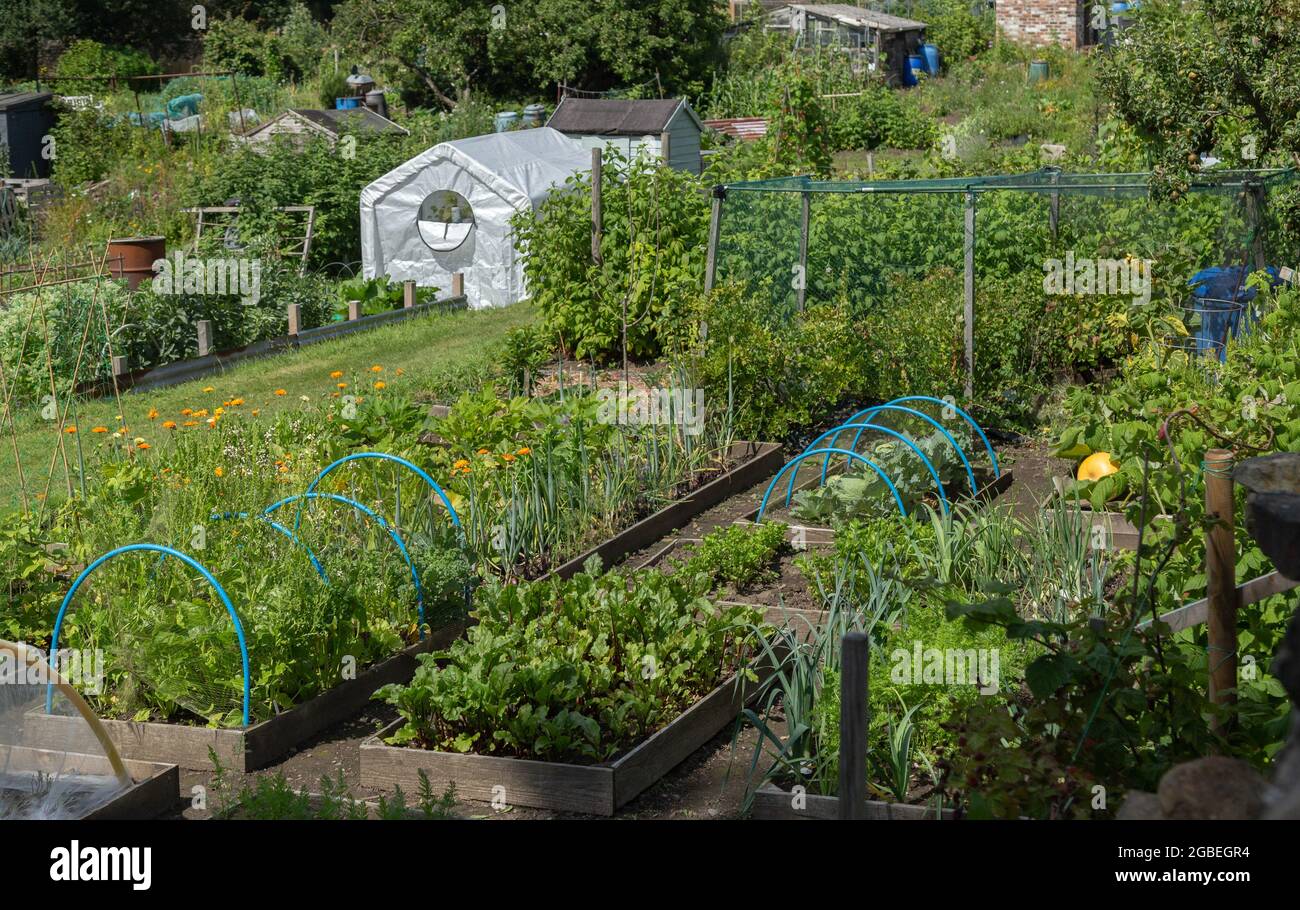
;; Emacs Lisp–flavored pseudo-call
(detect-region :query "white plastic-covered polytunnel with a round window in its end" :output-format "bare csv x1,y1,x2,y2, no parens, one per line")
361,127,592,309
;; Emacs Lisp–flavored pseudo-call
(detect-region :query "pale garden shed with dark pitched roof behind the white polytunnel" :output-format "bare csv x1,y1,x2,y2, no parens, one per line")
546,98,705,174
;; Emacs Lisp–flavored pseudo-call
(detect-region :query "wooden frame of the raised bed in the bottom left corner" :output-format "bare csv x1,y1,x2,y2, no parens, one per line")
0,748,181,820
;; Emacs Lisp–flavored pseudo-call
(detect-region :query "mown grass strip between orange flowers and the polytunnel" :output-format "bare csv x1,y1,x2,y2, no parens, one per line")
0,303,534,508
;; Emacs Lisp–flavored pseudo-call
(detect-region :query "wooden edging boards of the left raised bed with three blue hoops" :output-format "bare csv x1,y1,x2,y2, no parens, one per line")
26,623,467,772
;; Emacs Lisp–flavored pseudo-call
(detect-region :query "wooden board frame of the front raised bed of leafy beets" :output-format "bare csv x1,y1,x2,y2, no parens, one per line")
361,672,767,815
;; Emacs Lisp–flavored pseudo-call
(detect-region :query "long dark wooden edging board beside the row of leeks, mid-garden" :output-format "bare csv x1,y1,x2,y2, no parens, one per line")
543,441,785,579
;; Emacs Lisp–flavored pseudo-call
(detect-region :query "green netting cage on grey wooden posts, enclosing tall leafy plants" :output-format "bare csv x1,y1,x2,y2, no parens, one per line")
706,168,1297,399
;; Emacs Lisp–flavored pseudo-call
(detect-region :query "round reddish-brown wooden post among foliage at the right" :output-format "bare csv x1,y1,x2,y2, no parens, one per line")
1205,449,1240,732
